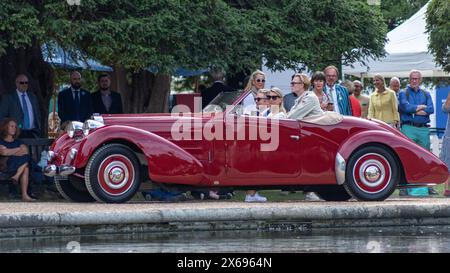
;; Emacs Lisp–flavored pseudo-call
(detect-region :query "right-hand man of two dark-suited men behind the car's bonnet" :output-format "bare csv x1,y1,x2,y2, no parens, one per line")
92,74,123,114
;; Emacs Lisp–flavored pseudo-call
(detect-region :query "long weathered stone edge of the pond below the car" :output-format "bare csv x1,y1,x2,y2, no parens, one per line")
0,202,450,237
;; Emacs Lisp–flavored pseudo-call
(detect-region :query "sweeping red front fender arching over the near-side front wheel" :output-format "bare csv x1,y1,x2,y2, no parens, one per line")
74,125,203,184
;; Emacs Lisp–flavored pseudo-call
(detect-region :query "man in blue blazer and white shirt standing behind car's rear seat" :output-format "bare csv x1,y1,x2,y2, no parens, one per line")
323,65,352,116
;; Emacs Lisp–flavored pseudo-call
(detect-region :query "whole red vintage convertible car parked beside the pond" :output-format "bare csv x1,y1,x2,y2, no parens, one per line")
45,92,449,203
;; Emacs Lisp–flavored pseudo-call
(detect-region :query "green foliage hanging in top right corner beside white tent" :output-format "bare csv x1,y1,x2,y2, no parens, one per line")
427,0,450,72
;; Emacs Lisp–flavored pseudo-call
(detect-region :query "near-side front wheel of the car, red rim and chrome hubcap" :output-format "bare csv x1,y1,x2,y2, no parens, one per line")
85,144,140,203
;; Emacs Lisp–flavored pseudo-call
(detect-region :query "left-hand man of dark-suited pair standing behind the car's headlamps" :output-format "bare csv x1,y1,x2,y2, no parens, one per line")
58,71,92,124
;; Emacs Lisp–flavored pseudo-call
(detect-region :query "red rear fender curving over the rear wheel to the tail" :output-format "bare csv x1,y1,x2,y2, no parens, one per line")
336,130,448,184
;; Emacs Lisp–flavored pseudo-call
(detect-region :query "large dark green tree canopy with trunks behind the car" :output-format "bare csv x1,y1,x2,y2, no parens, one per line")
0,0,386,126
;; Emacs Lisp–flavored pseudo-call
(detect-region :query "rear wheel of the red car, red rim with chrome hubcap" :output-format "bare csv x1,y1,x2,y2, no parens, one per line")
344,146,400,201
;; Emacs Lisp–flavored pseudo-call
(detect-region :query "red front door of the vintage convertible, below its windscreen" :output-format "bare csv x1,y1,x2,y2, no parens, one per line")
225,115,302,182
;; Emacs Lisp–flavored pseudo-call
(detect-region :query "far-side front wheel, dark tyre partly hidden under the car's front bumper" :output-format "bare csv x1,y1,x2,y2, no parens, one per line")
55,176,95,203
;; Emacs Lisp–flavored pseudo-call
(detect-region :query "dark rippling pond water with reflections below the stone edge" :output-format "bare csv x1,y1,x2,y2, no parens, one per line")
0,227,450,253
